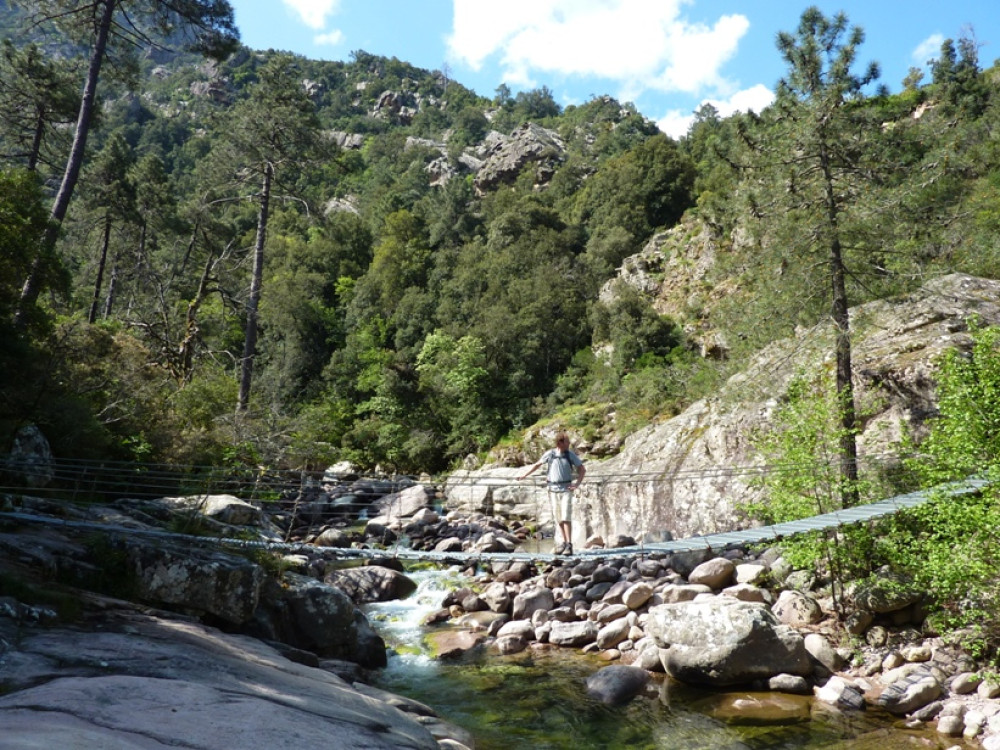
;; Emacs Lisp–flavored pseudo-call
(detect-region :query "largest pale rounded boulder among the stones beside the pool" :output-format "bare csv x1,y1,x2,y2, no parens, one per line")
646,596,812,687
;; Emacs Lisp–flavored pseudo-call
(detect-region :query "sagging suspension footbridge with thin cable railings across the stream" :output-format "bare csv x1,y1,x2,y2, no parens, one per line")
0,461,992,565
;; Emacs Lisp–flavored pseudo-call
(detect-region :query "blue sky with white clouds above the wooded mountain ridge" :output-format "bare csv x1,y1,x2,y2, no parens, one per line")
230,0,1000,137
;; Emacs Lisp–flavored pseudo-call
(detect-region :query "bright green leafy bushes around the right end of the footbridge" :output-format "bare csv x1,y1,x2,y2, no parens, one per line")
747,325,1000,655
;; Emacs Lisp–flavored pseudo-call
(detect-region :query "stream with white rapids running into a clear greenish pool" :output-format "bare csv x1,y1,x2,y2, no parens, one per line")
365,571,968,750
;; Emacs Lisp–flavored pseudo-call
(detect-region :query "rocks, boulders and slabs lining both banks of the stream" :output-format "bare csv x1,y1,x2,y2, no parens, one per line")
0,490,1000,750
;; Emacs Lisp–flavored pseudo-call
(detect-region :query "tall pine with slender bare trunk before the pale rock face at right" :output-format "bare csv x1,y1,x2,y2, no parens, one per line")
742,7,879,506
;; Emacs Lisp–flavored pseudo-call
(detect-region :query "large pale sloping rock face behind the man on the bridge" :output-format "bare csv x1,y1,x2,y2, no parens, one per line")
456,275,1000,543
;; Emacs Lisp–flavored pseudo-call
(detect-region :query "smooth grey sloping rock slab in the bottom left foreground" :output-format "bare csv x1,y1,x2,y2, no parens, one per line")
0,600,454,750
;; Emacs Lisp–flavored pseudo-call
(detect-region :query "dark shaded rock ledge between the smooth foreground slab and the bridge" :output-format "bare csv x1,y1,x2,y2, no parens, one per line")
0,516,388,667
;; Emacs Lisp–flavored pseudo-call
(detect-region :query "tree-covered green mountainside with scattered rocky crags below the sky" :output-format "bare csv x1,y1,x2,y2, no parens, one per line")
0,0,1000,472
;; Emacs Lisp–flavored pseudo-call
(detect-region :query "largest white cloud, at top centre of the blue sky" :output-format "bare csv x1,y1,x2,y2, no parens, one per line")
447,0,750,100
